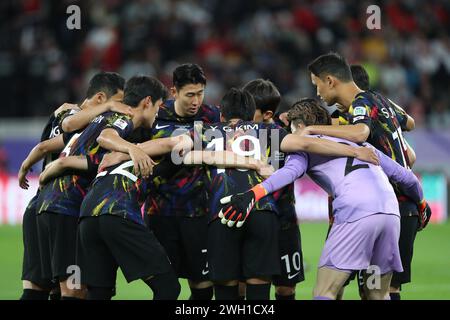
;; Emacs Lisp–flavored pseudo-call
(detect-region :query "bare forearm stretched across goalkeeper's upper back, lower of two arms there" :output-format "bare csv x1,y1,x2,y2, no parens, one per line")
281,134,357,157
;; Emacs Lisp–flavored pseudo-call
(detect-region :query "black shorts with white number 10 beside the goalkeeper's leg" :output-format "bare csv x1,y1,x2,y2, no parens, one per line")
272,224,305,287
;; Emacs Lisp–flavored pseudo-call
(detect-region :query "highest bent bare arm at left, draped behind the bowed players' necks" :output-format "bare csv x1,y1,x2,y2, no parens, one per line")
61,100,133,132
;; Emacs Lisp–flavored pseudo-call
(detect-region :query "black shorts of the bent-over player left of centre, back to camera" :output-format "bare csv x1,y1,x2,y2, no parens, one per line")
77,215,173,288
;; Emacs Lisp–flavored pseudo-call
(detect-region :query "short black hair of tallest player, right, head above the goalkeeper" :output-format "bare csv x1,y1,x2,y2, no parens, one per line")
308,52,353,82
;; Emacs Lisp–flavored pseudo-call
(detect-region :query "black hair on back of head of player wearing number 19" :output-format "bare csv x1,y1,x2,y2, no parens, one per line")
220,88,256,121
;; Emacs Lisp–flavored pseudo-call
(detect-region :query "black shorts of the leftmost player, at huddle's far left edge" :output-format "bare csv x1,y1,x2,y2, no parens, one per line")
22,195,52,289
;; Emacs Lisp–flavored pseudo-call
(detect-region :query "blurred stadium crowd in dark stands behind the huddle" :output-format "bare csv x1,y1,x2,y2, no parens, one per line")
0,0,450,128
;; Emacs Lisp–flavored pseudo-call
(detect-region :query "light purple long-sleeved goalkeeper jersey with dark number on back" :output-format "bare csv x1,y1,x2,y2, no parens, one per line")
262,136,423,224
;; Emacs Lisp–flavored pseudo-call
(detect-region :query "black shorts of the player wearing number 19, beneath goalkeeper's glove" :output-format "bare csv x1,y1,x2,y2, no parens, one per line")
208,211,280,282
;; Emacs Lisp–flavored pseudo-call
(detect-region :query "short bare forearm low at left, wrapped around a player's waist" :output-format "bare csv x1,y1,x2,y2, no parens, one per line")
39,156,88,186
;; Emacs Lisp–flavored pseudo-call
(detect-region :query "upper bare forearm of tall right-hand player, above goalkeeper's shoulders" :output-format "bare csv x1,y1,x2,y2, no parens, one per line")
306,123,370,143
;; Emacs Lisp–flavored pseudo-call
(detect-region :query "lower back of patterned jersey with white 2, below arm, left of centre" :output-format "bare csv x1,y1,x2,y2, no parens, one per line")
80,161,150,225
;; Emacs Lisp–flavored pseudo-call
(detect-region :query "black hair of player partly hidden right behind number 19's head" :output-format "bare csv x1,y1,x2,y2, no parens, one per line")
242,79,281,114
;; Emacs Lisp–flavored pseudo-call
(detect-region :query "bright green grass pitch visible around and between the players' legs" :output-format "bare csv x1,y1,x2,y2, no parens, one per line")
0,223,450,300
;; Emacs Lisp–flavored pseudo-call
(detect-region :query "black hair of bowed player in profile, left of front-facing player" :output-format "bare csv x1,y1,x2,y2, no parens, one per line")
123,76,168,108
